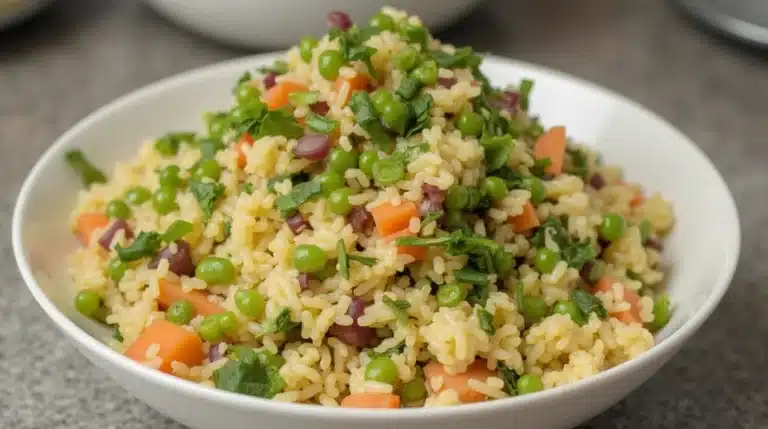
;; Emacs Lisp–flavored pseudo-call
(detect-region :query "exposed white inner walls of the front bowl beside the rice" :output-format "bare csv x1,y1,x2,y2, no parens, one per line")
13,55,740,388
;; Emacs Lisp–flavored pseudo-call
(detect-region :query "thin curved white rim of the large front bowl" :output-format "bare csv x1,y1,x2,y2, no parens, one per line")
11,52,741,421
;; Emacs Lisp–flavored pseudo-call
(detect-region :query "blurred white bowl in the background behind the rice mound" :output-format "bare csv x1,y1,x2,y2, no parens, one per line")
145,0,482,48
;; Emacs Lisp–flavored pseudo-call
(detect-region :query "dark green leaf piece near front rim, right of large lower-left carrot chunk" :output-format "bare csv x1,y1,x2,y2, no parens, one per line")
213,347,285,399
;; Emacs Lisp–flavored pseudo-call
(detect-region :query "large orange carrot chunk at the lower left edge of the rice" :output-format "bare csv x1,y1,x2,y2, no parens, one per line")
125,320,205,374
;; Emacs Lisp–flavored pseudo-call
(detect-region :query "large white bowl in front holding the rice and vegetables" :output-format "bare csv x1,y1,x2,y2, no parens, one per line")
13,55,740,429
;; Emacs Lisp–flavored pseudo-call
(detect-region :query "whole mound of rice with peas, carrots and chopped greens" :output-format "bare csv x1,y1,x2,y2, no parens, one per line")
67,8,674,408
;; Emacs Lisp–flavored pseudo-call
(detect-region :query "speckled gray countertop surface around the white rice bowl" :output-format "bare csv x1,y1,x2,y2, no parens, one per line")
0,0,768,429
